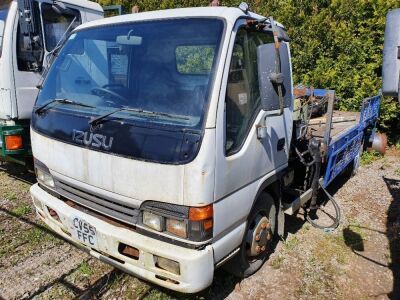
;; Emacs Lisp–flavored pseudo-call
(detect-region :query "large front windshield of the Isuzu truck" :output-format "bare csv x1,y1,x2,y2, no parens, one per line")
36,18,224,129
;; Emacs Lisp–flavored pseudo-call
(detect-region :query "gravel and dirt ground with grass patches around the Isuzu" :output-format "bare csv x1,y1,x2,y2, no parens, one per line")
0,150,400,299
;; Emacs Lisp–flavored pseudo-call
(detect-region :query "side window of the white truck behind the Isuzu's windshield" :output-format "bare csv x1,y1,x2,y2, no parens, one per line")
42,3,82,52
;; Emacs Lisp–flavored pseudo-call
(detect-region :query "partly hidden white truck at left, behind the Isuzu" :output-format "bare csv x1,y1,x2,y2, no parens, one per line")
0,0,103,164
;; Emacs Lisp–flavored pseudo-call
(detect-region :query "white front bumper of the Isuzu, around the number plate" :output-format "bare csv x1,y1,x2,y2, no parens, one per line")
30,184,214,293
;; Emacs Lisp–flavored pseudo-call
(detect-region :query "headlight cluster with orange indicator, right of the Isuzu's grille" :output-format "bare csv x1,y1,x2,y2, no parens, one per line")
141,201,213,242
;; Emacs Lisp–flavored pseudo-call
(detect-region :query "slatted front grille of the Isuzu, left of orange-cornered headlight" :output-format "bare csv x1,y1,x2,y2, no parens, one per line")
55,180,140,225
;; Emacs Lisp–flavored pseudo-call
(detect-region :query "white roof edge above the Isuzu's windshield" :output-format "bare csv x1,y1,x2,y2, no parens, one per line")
76,6,284,30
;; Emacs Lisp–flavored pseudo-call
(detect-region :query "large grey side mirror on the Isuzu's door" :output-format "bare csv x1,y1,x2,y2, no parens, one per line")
257,43,292,111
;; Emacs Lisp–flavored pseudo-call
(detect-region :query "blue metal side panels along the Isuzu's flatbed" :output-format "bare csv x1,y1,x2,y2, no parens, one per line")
324,95,381,187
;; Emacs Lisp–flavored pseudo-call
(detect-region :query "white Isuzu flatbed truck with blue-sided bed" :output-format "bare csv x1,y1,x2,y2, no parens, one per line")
31,4,382,293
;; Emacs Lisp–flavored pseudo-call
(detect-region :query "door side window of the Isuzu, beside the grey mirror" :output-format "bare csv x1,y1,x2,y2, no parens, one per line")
225,28,273,155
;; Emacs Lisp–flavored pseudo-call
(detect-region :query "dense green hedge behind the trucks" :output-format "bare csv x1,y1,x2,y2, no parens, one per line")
98,0,400,140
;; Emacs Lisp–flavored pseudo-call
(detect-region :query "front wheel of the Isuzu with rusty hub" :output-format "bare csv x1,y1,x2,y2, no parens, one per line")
224,192,277,278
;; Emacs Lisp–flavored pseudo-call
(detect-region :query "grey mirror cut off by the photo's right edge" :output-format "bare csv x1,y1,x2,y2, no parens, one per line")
382,9,400,98
